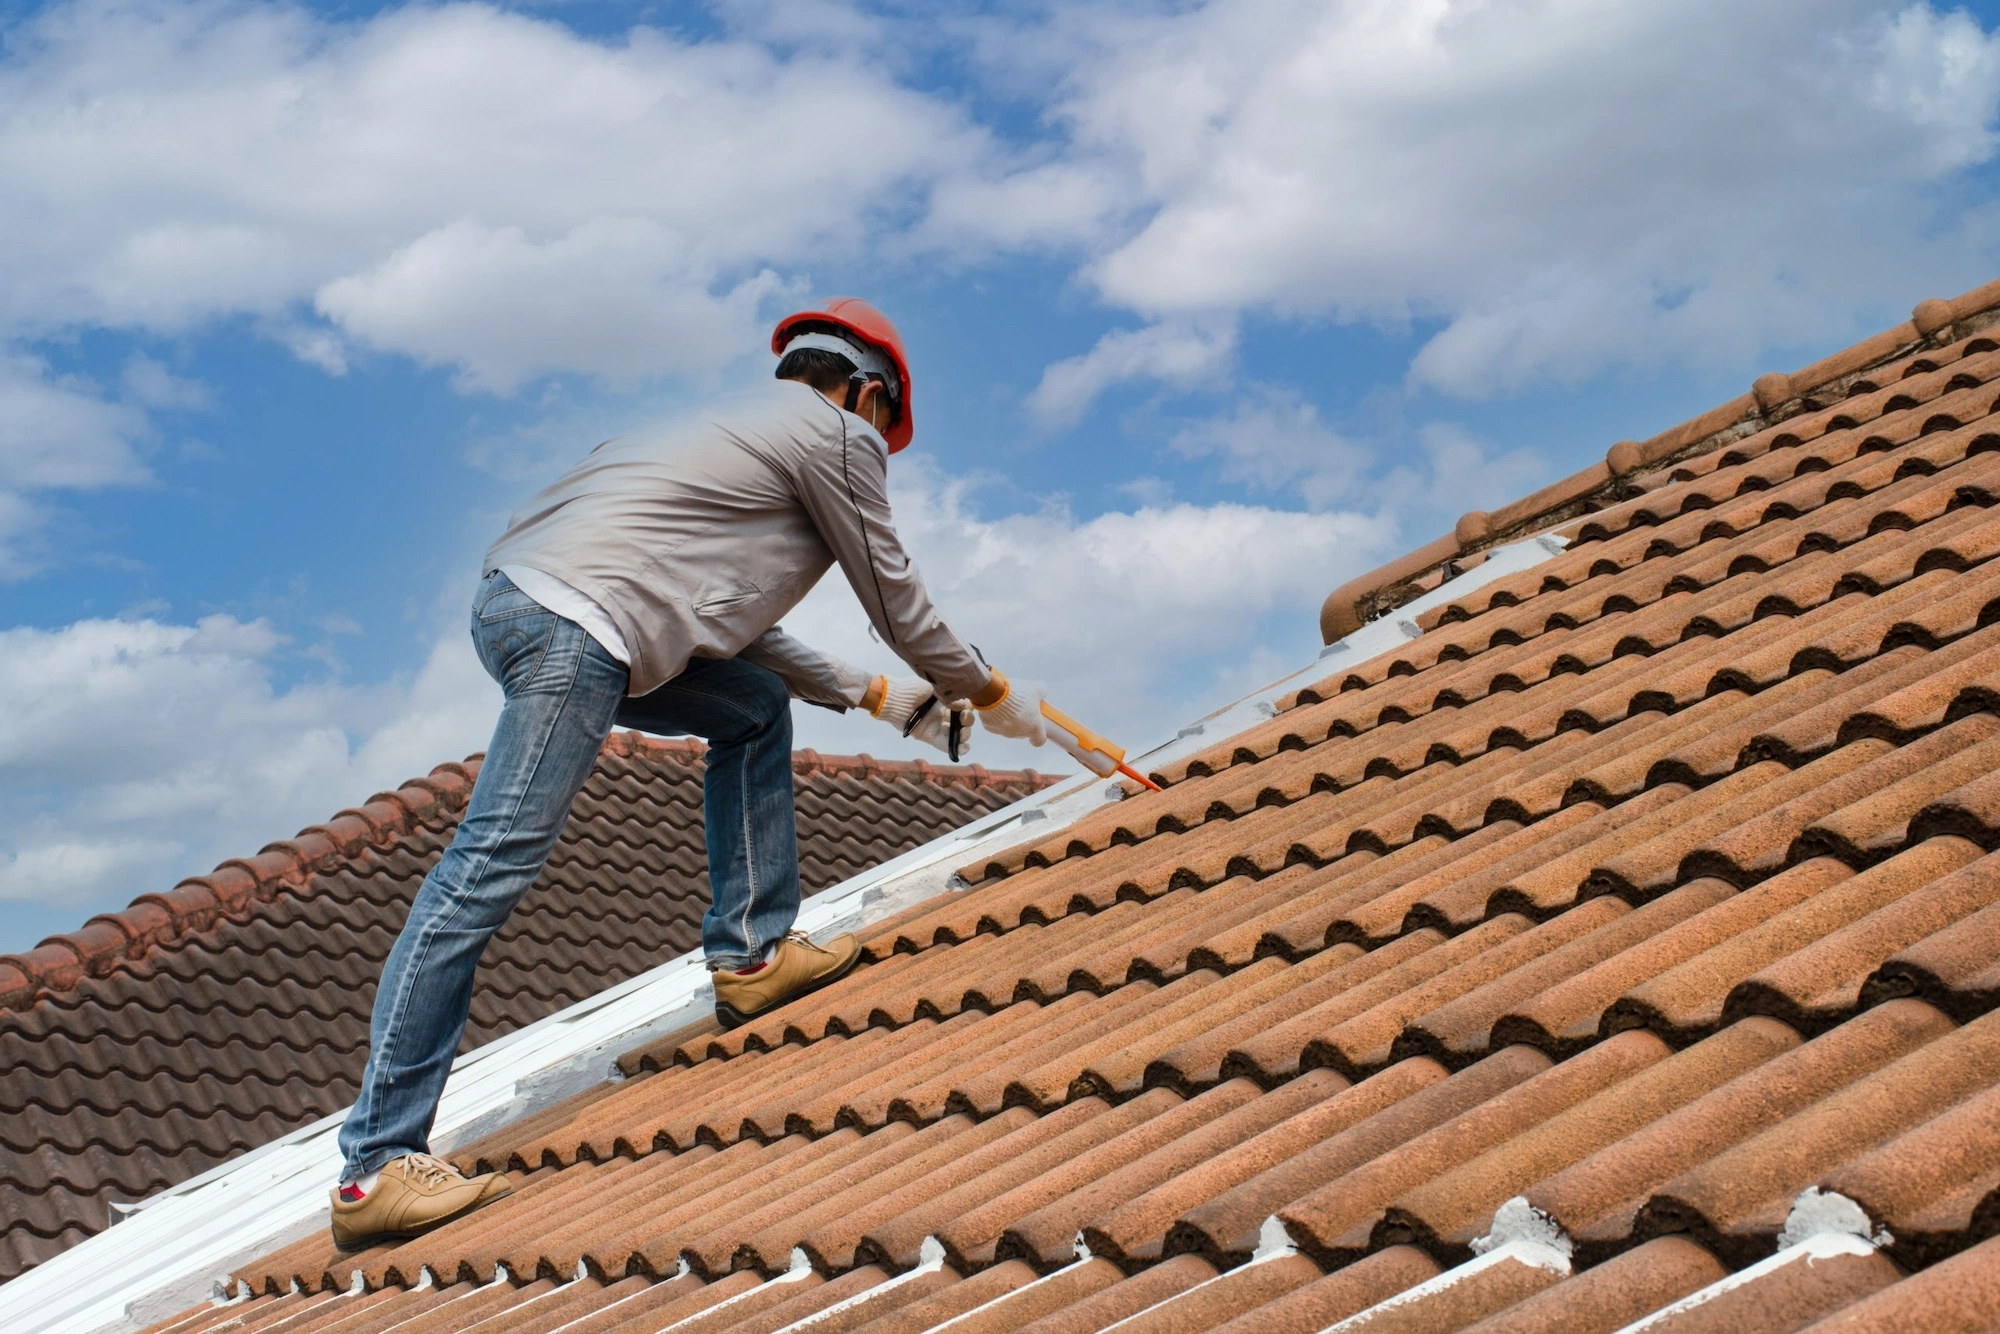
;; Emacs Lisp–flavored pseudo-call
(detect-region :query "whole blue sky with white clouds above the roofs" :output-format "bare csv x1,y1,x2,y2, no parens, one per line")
0,0,2000,950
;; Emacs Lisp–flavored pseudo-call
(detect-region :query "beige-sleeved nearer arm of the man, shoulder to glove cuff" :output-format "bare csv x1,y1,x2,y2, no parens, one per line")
800,406,992,700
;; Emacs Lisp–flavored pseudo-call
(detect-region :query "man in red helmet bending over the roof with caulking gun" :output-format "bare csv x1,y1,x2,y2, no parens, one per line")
332,298,1046,1250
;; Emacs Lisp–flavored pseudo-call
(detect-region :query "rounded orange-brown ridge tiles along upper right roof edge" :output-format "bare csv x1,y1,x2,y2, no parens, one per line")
1320,278,2000,644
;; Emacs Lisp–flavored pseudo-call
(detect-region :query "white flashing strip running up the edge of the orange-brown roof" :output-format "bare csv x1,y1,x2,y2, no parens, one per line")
0,534,1564,1334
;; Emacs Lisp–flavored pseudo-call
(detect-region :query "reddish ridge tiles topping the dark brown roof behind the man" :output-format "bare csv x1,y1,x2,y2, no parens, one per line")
0,730,1044,1012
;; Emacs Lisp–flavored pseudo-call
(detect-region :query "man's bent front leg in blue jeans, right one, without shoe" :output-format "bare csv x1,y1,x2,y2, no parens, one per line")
618,658,798,970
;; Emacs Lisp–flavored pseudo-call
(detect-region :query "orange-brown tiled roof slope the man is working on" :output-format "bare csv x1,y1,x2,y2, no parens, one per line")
141,284,2000,1334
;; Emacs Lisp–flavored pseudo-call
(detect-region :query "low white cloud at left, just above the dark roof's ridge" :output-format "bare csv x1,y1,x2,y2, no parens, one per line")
0,616,498,914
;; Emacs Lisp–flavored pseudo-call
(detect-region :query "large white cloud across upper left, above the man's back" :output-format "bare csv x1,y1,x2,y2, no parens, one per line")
0,0,986,388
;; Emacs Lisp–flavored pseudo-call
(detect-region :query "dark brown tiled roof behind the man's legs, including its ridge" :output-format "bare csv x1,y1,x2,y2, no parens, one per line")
0,732,1048,1278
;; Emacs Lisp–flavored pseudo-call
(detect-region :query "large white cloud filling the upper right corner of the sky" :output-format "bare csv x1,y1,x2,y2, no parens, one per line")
994,0,2000,396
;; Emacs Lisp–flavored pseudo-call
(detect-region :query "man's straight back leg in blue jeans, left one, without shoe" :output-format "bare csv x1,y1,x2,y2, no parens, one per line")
340,574,626,1180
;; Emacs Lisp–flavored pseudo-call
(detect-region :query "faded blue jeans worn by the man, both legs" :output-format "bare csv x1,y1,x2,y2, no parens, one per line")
340,572,798,1178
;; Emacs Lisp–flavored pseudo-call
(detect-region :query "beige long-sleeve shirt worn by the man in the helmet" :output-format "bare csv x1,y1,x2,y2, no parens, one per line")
484,380,990,708
